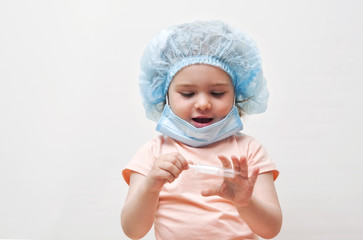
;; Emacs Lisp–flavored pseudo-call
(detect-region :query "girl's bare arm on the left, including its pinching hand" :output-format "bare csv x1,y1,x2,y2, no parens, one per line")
121,153,188,239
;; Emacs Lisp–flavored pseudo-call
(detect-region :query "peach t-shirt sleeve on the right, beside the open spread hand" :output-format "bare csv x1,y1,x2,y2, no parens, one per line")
247,138,279,180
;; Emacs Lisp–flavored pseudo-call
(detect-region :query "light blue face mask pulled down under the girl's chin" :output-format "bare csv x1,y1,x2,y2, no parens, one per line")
156,104,243,147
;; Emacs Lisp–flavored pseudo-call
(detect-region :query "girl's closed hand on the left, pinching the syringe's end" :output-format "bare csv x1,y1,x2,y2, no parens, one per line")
146,153,189,192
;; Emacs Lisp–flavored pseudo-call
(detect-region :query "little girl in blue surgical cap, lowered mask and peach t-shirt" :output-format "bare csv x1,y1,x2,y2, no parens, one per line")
121,21,282,240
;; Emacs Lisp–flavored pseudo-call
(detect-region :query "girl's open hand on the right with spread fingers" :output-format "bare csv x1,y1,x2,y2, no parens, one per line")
202,155,260,207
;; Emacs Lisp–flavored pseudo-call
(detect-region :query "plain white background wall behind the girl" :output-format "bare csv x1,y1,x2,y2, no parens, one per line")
0,0,363,240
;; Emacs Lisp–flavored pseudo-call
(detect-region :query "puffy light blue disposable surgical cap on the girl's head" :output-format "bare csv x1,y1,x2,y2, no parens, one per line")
139,21,269,121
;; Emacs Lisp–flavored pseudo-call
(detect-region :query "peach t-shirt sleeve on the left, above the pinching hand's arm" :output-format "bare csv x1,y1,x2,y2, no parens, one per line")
122,140,155,184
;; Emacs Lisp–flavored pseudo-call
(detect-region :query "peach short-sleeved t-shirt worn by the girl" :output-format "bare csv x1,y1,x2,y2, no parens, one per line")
122,134,279,240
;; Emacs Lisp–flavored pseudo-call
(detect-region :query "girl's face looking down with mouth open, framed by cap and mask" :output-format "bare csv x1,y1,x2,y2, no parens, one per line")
168,64,234,128
